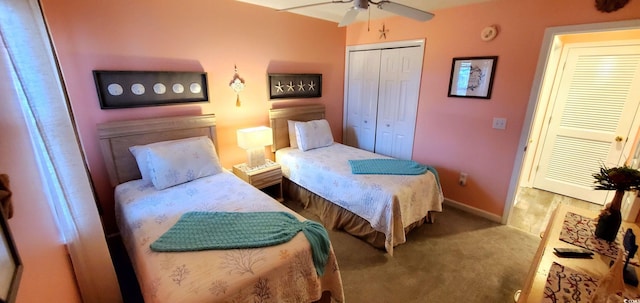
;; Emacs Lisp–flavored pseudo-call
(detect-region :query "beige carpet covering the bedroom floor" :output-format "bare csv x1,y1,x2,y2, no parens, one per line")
287,203,540,303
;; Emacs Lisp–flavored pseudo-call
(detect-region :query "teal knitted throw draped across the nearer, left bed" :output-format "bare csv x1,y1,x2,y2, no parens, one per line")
151,211,331,276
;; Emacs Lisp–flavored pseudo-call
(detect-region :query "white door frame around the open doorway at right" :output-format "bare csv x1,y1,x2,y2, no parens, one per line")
501,20,640,224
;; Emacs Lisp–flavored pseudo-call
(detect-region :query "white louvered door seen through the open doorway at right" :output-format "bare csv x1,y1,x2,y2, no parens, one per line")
534,44,640,204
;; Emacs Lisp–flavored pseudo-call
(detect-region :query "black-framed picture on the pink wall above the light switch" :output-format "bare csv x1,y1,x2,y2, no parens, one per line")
447,56,498,99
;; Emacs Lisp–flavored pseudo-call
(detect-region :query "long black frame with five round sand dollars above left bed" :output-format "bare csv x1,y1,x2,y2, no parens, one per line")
93,70,209,109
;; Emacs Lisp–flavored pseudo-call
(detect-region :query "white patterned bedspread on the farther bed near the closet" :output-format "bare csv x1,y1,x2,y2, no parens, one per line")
276,143,444,255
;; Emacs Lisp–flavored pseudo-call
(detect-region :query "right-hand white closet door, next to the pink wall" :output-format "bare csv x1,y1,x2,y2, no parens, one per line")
374,47,423,160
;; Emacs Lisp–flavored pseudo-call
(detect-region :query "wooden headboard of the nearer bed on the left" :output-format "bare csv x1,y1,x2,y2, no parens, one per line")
98,114,218,186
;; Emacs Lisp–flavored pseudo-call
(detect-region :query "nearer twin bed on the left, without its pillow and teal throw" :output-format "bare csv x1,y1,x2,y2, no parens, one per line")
98,115,344,303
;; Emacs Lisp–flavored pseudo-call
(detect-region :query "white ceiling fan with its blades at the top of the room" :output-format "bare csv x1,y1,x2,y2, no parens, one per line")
279,0,434,27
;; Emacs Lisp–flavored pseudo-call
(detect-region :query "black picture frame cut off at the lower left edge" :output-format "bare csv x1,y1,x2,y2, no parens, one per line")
0,211,23,303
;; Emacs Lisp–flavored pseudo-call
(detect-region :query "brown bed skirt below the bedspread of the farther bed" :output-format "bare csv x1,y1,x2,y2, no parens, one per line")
282,178,433,254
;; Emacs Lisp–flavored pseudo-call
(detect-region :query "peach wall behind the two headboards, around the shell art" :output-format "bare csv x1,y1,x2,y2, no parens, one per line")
41,0,346,233
